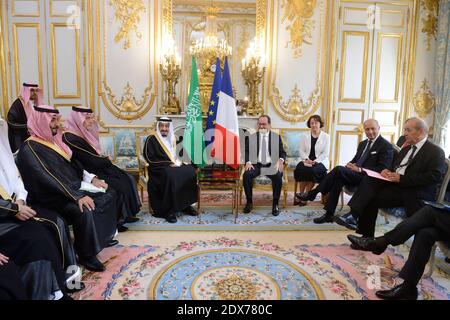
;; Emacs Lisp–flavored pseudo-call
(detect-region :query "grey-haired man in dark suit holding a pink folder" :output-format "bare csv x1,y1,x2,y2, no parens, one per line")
335,118,446,237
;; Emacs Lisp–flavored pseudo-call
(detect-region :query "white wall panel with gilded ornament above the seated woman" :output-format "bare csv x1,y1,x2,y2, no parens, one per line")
268,0,329,123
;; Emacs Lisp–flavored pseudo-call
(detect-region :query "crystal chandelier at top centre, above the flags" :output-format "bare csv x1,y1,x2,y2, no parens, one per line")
189,5,232,61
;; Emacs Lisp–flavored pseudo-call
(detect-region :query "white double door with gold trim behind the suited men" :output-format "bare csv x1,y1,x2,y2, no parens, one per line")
331,0,413,165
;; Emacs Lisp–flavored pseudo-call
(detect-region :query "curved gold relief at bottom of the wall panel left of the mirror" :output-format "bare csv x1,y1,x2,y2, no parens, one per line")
103,82,154,121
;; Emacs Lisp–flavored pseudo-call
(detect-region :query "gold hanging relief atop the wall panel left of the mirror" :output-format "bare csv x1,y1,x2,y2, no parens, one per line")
110,0,146,50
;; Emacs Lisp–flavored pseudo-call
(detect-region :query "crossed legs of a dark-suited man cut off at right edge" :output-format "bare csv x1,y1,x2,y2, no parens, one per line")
348,202,450,300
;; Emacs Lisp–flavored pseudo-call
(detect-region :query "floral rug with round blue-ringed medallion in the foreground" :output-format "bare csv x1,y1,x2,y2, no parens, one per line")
74,237,450,300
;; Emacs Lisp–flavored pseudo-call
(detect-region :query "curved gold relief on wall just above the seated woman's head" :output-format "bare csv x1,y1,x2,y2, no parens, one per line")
270,84,321,122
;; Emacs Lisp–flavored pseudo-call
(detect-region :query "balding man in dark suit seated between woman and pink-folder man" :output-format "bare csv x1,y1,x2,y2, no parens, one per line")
296,119,394,223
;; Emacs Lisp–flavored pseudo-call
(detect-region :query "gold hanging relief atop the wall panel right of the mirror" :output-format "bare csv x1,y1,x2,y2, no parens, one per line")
281,0,317,59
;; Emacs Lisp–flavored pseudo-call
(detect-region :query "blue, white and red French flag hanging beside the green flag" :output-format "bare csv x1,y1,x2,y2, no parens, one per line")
213,58,241,169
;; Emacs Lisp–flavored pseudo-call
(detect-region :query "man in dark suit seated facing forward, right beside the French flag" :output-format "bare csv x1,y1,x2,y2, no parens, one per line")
243,115,286,216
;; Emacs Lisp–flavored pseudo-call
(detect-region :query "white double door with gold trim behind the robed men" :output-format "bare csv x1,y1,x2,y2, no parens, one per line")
1,0,86,115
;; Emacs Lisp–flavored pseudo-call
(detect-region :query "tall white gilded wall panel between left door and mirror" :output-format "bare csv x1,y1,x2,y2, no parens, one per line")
94,0,158,127
